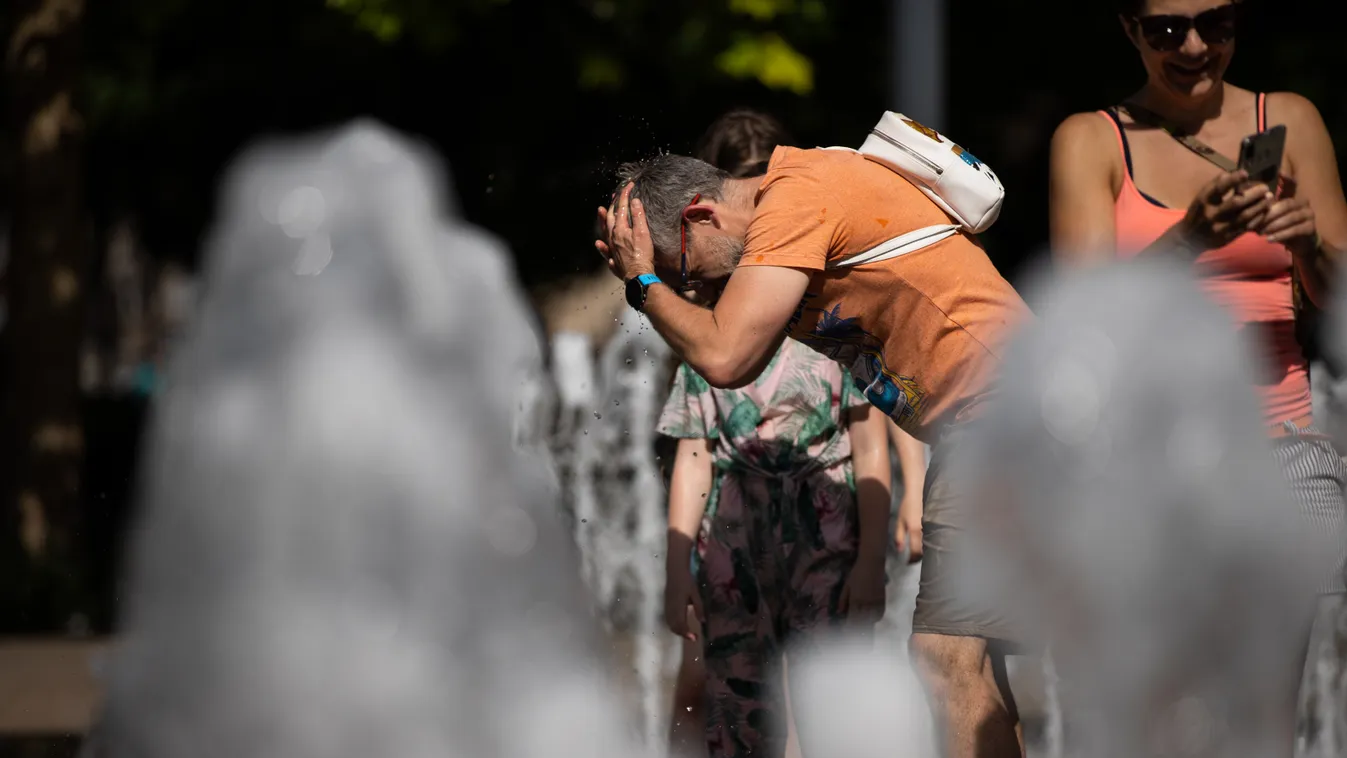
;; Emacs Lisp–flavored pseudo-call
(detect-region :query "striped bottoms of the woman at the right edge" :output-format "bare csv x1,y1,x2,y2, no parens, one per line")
1273,421,1347,594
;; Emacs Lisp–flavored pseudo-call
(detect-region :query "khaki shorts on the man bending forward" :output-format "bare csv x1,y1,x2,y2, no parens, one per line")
912,425,1024,642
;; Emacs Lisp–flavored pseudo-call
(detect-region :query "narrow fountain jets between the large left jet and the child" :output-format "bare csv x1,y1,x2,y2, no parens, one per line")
551,311,676,749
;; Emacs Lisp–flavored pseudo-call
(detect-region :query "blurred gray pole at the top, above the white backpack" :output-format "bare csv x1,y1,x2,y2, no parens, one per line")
890,0,947,129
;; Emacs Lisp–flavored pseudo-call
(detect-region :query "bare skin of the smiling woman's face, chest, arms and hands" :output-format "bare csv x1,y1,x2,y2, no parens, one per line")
1049,0,1347,304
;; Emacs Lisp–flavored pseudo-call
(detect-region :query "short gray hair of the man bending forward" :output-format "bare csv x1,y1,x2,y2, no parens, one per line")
617,155,730,257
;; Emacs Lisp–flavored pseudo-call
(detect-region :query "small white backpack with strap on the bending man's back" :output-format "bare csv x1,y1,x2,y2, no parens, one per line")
828,112,1006,268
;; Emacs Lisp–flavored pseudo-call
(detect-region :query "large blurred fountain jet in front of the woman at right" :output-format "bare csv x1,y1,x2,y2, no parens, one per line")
963,263,1332,758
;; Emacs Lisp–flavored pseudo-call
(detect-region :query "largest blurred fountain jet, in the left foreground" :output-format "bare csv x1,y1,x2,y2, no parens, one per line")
102,124,641,758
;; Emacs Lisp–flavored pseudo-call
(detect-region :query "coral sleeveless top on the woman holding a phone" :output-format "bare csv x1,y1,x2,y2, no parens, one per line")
1099,93,1311,428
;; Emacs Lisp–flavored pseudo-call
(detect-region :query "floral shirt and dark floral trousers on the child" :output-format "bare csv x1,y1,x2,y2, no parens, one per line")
657,339,866,758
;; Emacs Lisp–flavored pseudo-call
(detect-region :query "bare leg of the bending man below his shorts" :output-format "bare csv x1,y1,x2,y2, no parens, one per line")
909,633,1024,758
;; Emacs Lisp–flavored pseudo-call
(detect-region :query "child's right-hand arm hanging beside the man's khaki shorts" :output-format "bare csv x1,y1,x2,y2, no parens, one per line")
839,405,890,621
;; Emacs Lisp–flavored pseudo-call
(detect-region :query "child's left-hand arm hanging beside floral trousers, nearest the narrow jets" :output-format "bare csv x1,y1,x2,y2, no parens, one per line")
664,439,714,640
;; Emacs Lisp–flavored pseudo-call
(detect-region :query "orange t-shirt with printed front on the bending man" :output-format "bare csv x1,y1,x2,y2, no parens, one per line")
740,147,1029,442
